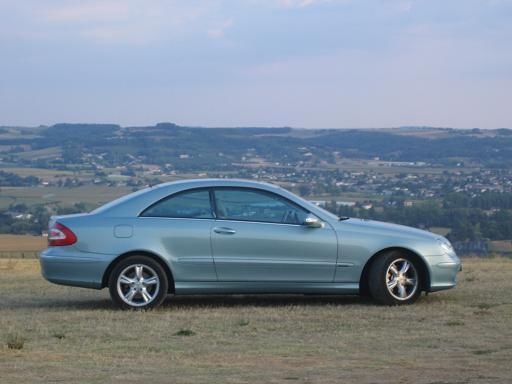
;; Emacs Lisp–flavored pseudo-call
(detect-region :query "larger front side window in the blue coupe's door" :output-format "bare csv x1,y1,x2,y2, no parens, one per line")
215,189,308,224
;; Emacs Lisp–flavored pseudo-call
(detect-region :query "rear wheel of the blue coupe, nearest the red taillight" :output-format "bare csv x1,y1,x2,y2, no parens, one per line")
108,256,169,310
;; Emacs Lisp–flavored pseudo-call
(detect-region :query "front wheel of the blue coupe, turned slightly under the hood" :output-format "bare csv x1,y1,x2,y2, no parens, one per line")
368,251,422,305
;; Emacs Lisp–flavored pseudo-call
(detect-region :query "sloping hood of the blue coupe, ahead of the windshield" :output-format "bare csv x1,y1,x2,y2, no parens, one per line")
338,218,442,240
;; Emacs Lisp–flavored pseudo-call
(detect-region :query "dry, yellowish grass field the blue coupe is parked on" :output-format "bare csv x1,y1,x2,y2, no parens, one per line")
0,258,512,384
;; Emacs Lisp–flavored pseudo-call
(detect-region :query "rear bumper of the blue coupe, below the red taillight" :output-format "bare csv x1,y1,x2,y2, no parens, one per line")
39,247,115,289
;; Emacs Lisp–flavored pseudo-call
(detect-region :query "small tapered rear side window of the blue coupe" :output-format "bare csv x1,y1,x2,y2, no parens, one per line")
141,189,213,219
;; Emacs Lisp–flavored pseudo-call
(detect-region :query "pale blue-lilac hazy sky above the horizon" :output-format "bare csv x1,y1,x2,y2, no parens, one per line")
0,0,512,128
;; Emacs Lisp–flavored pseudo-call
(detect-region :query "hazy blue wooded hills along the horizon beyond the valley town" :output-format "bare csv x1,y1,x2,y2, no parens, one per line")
0,123,512,169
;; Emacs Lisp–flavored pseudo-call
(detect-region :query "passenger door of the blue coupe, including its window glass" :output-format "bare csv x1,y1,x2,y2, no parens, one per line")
211,187,337,282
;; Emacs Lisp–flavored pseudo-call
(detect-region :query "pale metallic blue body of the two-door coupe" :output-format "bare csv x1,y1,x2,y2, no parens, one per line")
40,179,461,307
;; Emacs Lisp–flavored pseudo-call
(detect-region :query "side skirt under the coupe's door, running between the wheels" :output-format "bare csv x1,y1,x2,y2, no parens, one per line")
175,281,359,295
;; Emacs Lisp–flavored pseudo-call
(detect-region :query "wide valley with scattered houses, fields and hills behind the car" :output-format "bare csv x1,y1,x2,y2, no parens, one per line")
0,123,512,255
